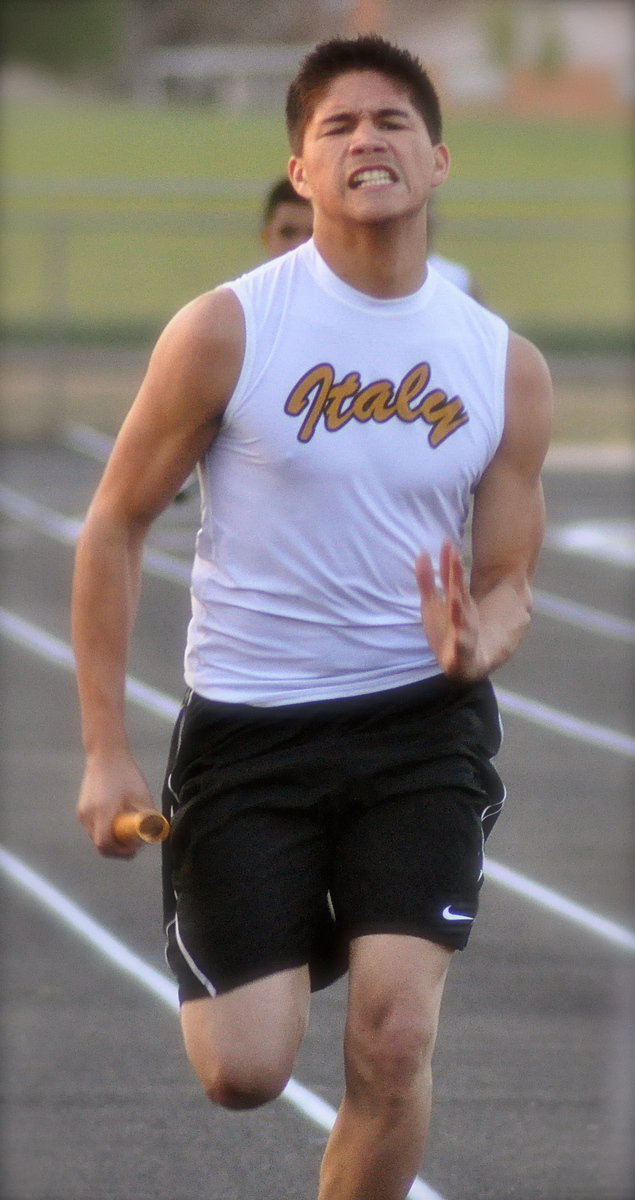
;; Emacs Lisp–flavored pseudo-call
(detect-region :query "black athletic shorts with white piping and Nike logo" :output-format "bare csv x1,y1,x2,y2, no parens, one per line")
163,676,504,1001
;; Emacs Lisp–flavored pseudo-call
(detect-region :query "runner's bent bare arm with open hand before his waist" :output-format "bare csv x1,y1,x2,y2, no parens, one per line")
417,334,552,679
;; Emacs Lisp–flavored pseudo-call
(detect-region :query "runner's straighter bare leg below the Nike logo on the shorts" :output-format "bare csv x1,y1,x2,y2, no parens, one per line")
318,935,453,1200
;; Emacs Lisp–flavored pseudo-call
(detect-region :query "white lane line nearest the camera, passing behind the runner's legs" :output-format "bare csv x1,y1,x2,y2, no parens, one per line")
0,846,443,1200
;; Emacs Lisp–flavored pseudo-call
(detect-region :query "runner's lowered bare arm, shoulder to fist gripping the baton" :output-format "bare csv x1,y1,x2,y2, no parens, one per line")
72,292,244,857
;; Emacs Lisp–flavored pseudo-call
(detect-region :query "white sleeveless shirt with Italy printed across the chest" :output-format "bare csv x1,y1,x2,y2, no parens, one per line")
185,241,508,706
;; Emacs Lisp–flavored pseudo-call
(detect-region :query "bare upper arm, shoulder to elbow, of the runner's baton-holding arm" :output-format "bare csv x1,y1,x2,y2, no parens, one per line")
84,290,244,524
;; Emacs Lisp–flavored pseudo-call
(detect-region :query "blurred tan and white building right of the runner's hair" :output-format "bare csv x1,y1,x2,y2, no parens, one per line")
390,0,635,115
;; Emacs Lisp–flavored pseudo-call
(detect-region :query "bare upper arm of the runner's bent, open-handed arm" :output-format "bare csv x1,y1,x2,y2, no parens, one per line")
471,335,552,598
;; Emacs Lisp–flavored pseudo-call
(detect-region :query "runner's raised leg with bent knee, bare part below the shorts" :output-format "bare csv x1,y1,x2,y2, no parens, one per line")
181,967,310,1109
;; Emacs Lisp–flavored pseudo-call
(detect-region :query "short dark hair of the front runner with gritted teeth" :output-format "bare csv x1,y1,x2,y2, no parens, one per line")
287,34,443,154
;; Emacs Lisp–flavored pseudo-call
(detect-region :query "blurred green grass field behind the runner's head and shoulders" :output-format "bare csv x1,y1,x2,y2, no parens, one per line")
2,101,635,347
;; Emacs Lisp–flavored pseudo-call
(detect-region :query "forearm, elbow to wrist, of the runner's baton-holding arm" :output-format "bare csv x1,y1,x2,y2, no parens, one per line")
72,514,143,755
